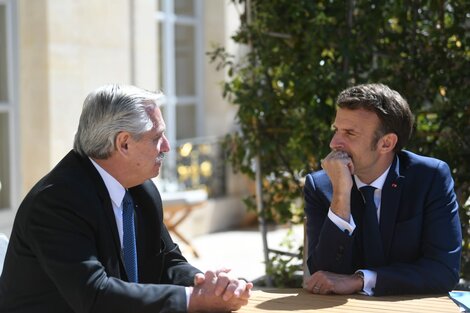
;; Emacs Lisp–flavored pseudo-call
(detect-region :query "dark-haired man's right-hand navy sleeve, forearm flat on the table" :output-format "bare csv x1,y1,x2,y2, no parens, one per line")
373,161,462,296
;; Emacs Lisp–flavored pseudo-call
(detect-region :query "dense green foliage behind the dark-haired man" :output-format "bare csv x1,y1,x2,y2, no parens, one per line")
210,0,470,276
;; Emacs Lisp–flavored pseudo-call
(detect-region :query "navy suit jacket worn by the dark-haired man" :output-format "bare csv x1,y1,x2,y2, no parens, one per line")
304,151,462,296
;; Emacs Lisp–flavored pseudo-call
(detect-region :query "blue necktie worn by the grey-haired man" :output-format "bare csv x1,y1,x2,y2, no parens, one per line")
122,191,138,283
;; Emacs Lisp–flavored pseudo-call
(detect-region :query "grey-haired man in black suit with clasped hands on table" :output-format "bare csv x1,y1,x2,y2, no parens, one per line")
0,85,253,313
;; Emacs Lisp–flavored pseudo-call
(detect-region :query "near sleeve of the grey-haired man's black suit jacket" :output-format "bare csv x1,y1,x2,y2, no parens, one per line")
24,184,186,313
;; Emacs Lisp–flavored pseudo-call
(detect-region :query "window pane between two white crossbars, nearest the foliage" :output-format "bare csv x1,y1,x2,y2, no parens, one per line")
175,25,196,96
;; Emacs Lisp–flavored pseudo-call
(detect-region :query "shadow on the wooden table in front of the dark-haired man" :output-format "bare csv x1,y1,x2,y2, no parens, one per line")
256,289,452,311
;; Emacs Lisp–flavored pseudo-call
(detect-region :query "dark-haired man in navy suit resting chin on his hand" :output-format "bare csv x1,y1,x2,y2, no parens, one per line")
304,84,462,296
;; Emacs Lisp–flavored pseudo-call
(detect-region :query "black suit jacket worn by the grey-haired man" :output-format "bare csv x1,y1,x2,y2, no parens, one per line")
0,151,200,313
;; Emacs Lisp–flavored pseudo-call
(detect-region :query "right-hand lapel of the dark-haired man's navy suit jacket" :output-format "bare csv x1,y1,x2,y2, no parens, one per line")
379,155,404,260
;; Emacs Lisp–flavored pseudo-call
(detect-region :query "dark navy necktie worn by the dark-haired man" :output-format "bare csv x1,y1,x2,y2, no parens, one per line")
360,186,384,267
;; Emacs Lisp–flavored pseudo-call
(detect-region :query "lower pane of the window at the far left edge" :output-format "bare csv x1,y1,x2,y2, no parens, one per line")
0,113,10,209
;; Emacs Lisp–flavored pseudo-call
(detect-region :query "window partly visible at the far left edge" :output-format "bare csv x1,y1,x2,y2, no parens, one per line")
0,0,18,211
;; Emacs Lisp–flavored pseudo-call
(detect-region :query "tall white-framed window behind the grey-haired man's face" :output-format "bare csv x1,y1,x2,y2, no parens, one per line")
155,0,204,186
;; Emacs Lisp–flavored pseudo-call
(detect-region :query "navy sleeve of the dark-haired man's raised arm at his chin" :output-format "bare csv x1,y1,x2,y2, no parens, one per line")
304,173,354,274
